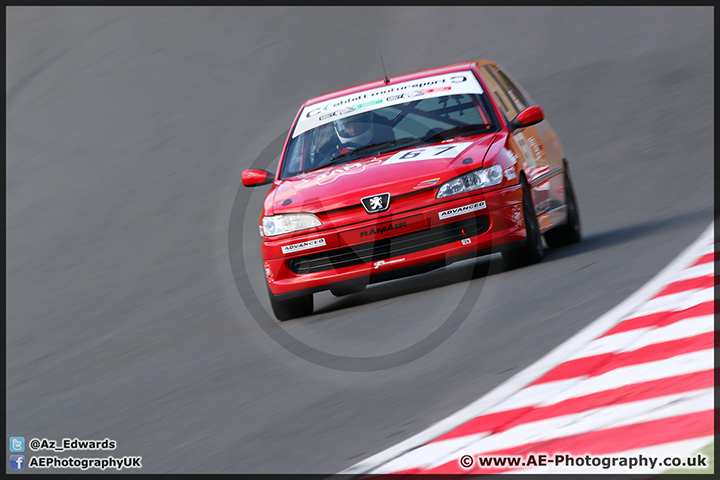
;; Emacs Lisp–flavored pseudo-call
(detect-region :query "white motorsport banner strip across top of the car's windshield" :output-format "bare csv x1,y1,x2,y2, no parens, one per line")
293,71,483,138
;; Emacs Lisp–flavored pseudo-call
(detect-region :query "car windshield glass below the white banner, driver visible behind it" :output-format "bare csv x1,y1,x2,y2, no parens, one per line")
280,93,497,179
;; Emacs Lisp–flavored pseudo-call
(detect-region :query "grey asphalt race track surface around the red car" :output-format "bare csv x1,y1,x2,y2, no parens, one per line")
6,7,714,473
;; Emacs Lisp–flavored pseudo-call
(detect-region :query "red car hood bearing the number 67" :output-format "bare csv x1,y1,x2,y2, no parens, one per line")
266,133,496,214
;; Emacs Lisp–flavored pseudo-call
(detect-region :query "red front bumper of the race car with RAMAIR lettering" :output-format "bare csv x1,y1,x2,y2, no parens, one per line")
263,185,526,298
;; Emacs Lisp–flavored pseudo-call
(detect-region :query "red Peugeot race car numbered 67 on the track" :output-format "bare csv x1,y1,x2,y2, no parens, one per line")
242,60,580,320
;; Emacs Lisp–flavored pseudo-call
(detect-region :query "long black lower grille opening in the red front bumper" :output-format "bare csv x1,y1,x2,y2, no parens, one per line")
288,216,490,274
